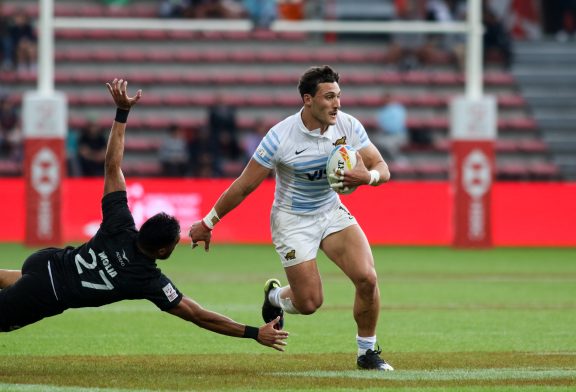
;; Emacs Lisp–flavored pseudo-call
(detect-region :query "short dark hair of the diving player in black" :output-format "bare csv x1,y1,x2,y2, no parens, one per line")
137,212,180,252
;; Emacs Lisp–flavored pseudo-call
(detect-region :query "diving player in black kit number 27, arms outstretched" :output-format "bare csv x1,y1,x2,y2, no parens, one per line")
0,79,288,351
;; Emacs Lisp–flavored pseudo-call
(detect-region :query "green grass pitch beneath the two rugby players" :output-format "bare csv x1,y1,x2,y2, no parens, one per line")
0,242,576,392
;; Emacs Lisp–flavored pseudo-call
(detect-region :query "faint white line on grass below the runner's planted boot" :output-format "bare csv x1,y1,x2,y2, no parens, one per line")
273,369,576,381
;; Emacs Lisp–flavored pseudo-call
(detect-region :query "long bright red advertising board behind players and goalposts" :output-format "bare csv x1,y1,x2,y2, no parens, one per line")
0,179,576,246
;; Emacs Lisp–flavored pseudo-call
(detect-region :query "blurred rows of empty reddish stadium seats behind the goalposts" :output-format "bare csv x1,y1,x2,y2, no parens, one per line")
0,0,561,180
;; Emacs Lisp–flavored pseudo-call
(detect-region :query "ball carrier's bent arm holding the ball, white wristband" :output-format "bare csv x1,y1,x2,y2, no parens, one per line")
343,143,390,187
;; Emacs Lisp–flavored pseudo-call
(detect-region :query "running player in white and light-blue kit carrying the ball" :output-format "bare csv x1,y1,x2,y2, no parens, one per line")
189,66,393,370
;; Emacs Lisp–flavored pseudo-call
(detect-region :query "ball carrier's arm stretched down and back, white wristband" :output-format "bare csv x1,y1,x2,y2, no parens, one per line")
188,159,271,250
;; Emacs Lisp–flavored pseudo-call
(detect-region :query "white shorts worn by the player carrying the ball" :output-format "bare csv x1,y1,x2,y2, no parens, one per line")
270,204,357,268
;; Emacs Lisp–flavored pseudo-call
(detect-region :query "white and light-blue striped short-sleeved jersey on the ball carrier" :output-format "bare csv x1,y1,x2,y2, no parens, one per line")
252,111,370,215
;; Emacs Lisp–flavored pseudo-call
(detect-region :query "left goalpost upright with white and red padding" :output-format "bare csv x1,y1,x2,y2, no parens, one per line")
22,0,68,246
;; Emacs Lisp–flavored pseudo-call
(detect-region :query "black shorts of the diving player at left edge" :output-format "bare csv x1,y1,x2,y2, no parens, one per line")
0,248,66,332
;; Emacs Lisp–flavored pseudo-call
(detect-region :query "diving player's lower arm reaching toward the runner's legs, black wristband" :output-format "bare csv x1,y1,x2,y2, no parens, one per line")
168,296,288,351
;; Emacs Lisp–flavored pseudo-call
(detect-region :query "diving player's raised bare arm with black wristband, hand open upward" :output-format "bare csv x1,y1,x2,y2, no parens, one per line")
104,79,142,195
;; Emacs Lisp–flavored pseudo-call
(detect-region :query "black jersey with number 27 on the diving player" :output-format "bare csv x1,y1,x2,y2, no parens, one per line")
51,191,182,310
